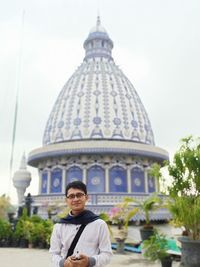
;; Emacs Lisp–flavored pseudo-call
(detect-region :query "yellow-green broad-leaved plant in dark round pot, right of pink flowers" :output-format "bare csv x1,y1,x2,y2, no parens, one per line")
134,194,162,241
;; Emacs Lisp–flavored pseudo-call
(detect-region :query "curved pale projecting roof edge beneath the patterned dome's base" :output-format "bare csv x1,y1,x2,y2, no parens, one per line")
28,140,169,167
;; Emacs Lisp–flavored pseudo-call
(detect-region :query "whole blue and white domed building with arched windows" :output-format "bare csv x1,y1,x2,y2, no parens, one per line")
28,17,168,220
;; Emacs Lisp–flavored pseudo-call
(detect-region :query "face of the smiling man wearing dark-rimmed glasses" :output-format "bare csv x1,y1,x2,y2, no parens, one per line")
66,188,88,215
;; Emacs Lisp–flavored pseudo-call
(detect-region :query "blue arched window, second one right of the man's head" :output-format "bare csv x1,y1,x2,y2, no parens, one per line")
109,166,127,192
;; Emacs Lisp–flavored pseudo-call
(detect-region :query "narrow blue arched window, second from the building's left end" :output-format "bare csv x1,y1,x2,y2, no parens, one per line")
50,168,62,193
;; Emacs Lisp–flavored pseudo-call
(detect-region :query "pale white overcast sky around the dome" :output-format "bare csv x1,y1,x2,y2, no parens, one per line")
0,0,200,205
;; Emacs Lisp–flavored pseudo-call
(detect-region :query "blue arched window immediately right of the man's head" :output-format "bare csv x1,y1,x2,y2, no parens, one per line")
87,165,105,192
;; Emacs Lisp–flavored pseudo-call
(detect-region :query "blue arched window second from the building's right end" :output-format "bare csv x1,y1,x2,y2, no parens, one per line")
131,167,145,193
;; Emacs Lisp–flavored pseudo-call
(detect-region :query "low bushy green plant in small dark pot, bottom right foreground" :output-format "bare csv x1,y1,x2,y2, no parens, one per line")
142,231,172,267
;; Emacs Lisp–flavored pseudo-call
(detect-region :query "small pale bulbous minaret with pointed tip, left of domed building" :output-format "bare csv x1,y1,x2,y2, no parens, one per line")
13,154,31,206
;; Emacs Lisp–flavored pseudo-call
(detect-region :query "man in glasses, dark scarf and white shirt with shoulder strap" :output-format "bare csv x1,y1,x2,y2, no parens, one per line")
49,181,112,267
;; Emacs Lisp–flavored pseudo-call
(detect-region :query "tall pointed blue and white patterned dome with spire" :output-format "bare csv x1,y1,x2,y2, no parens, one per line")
43,17,154,145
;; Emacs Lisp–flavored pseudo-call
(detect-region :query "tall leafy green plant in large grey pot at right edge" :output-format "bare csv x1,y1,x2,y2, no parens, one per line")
157,136,200,267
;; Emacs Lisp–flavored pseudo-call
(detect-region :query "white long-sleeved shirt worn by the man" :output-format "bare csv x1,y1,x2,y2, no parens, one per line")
49,219,112,267
